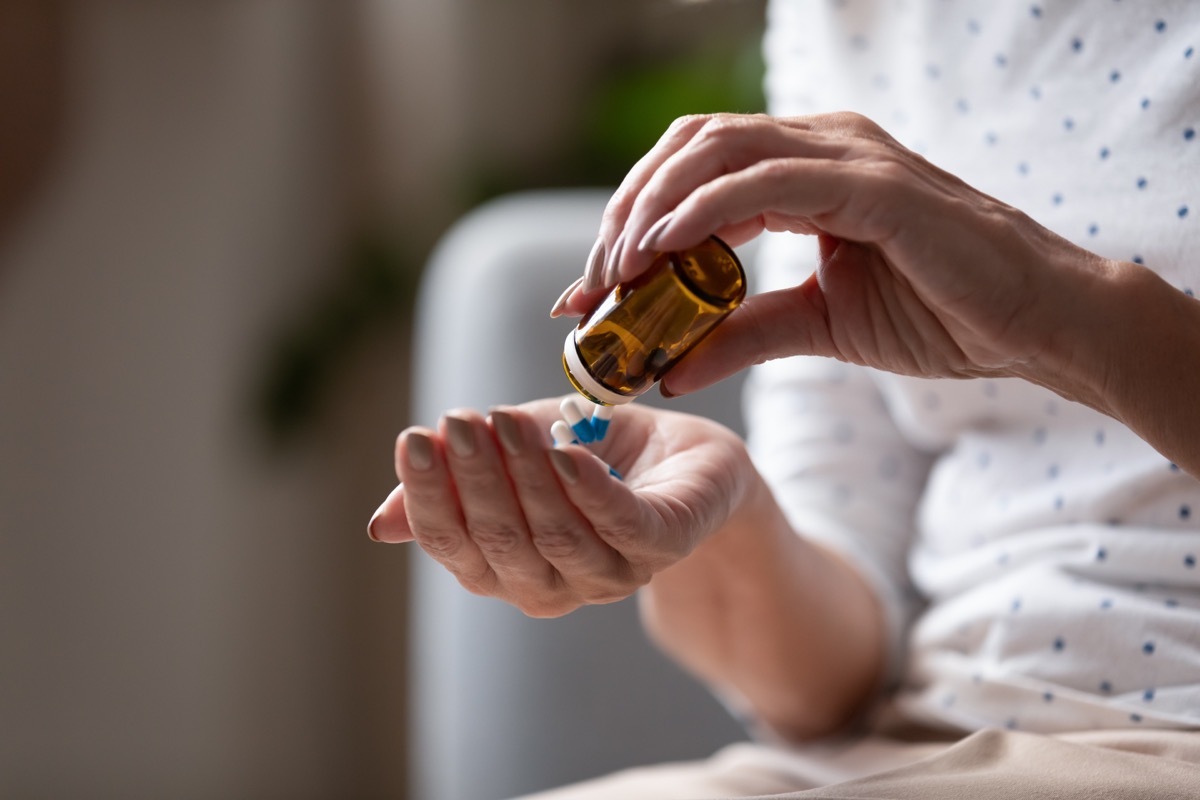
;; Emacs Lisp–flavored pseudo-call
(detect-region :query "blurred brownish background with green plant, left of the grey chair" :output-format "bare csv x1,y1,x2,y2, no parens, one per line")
0,0,762,800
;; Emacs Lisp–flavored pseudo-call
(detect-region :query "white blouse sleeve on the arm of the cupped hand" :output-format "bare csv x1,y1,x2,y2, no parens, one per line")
745,234,931,685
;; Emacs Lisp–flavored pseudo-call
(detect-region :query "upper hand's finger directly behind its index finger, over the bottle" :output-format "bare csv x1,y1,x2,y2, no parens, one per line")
618,115,853,281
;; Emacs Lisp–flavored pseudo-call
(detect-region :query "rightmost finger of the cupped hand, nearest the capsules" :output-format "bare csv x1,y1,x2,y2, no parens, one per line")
548,445,688,568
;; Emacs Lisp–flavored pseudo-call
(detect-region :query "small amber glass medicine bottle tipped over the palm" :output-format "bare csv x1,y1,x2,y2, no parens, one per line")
563,236,746,405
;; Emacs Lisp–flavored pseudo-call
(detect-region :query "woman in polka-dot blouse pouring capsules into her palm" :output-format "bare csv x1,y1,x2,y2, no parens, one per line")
372,0,1200,799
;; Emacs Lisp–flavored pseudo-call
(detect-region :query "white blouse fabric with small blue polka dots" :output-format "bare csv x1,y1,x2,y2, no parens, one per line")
751,0,1200,730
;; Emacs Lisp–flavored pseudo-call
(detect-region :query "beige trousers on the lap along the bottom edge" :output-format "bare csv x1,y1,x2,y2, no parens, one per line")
524,730,1200,800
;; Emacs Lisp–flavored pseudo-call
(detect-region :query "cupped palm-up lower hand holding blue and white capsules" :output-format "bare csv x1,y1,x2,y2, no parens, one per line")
370,399,752,616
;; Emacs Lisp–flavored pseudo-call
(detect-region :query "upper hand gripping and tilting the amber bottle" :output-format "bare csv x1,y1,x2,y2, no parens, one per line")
556,108,1116,393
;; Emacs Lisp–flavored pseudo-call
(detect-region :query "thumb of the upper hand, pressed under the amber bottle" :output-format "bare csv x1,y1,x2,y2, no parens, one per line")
660,273,835,397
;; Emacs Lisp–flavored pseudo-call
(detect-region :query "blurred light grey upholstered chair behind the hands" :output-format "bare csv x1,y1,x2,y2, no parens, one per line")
410,191,745,800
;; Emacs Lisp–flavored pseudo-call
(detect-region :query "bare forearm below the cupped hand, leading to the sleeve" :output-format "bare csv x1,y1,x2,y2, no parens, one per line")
641,475,884,740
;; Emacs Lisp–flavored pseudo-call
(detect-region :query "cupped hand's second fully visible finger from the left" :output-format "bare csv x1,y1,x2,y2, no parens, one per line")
440,411,556,588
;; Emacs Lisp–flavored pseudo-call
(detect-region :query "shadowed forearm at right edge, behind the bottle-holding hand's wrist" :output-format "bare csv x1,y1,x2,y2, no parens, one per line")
1028,263,1200,477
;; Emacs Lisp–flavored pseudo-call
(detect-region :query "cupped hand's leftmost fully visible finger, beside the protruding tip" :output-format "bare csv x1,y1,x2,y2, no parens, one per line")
396,428,497,594
